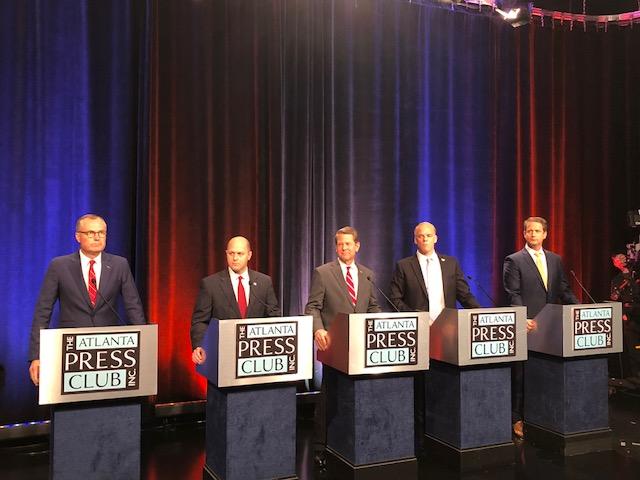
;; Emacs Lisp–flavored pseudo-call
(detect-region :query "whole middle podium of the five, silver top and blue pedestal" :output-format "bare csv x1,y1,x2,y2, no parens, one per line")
317,312,429,478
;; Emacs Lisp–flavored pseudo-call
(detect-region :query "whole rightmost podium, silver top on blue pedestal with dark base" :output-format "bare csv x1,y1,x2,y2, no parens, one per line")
524,302,623,456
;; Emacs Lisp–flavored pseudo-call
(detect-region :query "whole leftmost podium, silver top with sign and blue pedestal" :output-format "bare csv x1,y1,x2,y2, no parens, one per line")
39,325,158,480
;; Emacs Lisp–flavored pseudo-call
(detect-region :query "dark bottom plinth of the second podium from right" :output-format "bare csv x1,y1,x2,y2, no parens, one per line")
424,435,514,472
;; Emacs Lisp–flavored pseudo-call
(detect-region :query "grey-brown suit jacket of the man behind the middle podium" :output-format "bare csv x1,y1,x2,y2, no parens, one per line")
304,260,380,332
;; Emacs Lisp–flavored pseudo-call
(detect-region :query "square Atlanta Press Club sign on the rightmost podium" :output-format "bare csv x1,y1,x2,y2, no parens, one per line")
573,307,613,350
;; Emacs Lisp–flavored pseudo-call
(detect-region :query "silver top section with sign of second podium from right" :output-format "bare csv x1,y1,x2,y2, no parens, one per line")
430,307,527,366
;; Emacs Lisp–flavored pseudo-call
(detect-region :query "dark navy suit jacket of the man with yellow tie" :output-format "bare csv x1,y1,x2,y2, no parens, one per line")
502,248,579,318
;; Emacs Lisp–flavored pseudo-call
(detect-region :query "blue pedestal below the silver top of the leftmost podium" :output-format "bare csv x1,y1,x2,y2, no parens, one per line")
51,401,140,480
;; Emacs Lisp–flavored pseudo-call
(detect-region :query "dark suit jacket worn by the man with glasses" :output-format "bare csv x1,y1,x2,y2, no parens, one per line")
29,252,146,360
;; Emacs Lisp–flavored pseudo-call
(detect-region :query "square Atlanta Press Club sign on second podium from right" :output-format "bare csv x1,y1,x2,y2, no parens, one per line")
471,312,516,358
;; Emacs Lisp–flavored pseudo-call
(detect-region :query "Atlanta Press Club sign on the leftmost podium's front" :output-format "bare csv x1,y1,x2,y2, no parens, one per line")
62,332,140,395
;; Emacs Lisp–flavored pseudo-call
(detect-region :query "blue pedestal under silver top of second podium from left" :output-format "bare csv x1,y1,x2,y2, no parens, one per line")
203,383,297,480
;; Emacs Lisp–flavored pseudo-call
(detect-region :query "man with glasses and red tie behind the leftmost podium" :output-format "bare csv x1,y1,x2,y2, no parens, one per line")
29,214,146,385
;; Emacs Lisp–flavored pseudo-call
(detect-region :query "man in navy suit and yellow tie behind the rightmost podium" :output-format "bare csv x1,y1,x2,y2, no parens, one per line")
502,217,578,438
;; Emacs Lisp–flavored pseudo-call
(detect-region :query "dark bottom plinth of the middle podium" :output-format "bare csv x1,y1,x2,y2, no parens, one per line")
326,447,418,480
